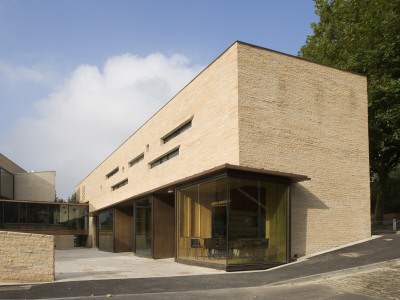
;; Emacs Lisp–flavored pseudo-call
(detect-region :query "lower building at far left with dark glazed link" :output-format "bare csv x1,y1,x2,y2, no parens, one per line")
0,153,88,248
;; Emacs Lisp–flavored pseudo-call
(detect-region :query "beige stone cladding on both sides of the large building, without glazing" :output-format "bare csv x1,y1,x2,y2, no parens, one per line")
77,42,371,256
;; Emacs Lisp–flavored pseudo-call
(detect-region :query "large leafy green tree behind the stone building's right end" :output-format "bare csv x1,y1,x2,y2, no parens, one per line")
298,0,400,221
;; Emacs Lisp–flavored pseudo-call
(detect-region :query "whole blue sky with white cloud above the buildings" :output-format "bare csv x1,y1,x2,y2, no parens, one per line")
0,0,318,199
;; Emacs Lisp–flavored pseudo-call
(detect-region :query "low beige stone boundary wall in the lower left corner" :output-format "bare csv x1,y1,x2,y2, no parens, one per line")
0,231,54,283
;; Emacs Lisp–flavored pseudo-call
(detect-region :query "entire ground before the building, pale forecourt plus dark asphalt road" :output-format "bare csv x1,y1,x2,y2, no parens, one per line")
0,234,400,300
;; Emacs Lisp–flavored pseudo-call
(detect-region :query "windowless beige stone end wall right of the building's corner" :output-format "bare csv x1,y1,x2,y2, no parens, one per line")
238,44,371,255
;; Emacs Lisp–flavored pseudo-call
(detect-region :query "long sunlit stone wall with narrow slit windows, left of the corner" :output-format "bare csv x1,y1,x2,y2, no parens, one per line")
77,44,239,211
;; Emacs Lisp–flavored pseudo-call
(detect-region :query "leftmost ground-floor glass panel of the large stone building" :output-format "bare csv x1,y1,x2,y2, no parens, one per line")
97,209,114,252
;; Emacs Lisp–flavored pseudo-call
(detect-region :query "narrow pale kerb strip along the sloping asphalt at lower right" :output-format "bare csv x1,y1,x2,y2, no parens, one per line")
265,258,400,286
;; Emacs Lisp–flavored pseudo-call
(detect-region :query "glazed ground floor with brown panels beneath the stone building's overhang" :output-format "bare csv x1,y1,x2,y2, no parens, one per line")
94,170,291,271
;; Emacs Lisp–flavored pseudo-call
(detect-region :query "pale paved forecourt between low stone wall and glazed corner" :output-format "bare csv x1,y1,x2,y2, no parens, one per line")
55,248,225,281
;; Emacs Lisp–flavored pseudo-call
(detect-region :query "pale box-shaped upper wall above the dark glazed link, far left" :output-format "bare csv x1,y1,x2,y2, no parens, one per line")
14,171,56,202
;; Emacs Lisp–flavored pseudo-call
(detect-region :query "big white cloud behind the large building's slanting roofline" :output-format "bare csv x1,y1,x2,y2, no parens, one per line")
0,53,201,199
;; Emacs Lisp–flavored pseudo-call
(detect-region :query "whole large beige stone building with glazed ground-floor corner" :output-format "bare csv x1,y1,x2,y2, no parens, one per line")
77,42,371,271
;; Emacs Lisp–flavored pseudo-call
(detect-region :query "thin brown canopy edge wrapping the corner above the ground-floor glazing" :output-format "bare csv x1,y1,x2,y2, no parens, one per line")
89,164,311,216
